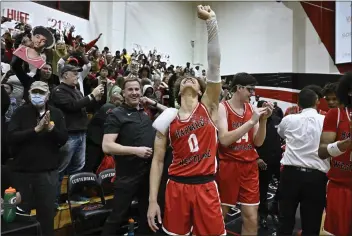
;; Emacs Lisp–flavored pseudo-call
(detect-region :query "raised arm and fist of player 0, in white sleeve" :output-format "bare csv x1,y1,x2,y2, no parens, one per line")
198,5,221,118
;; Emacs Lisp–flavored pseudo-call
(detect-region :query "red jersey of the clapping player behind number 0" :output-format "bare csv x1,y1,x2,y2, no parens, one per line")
219,101,258,162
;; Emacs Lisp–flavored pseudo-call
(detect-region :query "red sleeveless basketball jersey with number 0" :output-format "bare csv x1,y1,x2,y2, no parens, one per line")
169,103,217,177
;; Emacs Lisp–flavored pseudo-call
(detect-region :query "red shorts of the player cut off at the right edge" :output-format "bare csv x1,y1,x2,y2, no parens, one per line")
324,181,352,236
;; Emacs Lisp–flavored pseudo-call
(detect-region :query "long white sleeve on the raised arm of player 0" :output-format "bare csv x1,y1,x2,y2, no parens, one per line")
206,17,221,83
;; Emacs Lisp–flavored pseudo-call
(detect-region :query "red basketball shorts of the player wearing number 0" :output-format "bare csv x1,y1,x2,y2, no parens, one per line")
163,180,226,235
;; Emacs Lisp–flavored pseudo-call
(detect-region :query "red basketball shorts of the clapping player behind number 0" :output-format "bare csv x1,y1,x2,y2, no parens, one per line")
217,160,260,206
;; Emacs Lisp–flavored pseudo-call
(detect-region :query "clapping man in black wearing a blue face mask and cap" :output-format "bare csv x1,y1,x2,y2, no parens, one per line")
8,81,68,235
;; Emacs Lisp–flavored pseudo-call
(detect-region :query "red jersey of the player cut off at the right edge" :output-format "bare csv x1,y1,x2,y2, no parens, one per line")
323,108,352,188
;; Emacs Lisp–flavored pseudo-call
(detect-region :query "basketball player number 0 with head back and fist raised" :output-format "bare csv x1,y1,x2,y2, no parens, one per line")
148,6,226,235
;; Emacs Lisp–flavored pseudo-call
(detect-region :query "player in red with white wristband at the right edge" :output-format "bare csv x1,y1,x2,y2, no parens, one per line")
318,73,352,236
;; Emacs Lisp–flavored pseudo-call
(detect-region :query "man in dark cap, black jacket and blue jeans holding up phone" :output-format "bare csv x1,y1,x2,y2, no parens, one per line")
51,64,104,203
